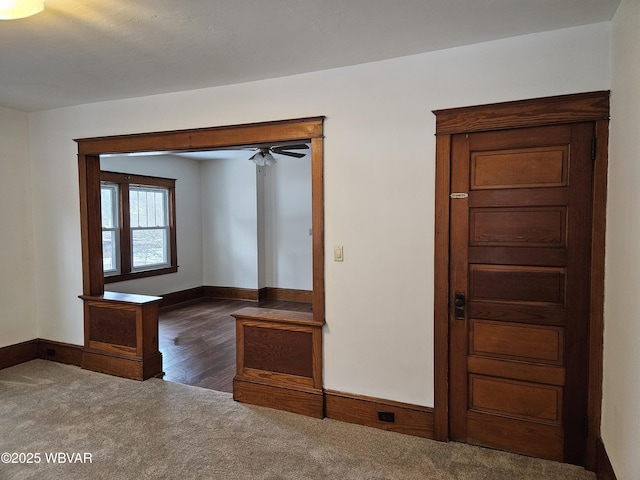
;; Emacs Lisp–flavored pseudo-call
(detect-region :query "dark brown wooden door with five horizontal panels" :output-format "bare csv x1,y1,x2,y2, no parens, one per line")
449,122,595,464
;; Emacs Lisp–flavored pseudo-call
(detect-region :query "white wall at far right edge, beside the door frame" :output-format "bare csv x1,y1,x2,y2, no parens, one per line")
602,0,640,480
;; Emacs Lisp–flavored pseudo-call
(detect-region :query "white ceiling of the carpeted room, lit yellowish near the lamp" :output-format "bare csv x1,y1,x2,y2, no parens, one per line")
0,0,619,111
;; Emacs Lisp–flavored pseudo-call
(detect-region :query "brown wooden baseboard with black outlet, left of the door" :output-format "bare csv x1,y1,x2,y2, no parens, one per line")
324,390,434,439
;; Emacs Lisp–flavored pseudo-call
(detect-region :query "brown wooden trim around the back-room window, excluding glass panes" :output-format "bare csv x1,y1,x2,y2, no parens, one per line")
100,170,178,283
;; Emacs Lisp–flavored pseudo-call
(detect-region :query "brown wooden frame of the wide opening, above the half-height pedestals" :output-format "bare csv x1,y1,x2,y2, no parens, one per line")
75,117,325,325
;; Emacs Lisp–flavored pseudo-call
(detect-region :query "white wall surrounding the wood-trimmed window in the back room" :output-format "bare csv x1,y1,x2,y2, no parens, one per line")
100,155,203,295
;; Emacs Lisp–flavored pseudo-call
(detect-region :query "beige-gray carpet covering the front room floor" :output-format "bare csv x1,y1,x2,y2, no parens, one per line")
0,360,595,480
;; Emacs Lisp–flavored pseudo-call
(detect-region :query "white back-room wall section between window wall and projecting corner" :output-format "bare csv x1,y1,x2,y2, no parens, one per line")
201,159,258,289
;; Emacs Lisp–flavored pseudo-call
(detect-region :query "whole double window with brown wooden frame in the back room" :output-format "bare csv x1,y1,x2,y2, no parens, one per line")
100,172,178,283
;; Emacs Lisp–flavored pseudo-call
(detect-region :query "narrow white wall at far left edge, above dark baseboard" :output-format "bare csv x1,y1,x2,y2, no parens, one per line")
0,107,37,347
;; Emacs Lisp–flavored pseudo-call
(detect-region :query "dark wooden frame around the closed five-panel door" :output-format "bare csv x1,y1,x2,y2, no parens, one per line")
433,91,610,470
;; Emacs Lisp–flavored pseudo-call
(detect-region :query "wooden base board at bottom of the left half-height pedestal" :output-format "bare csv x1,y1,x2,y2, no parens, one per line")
81,350,162,380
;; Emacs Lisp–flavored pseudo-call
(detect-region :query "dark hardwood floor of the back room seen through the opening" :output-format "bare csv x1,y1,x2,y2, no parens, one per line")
158,298,311,392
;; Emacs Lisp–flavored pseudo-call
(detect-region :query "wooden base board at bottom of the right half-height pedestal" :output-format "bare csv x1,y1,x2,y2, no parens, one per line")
233,378,324,418
